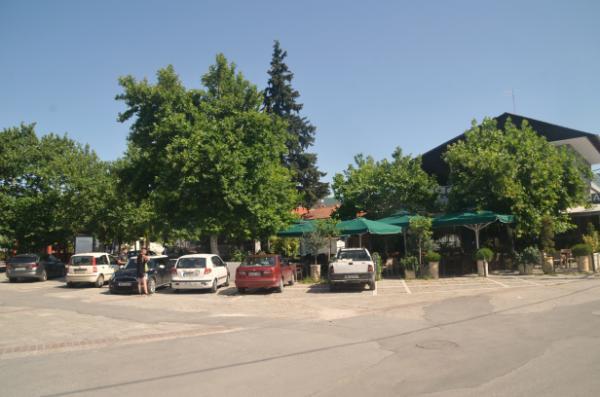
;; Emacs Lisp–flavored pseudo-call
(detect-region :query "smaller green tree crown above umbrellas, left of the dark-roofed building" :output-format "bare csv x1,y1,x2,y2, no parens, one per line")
332,148,437,219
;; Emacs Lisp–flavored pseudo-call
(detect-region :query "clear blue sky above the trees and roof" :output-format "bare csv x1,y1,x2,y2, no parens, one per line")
0,0,600,181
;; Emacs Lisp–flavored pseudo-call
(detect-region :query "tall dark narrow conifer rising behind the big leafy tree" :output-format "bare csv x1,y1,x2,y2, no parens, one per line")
264,40,329,208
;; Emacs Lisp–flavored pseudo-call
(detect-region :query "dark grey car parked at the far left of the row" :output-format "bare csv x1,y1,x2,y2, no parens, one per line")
6,254,65,283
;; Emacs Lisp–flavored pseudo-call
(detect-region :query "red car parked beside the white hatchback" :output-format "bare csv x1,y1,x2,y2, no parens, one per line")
235,254,296,294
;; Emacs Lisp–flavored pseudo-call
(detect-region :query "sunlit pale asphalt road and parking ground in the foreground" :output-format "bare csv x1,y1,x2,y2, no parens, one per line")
0,277,600,396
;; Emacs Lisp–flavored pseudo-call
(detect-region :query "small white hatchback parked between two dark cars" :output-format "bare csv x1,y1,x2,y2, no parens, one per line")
65,252,119,288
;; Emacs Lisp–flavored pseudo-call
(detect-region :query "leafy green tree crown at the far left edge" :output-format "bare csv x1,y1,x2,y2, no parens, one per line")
0,124,120,251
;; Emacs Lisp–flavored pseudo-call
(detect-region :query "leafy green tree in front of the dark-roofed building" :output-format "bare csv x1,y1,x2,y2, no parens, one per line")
444,118,591,242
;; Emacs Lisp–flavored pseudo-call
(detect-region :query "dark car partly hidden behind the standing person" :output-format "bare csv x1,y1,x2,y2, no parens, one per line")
110,255,172,294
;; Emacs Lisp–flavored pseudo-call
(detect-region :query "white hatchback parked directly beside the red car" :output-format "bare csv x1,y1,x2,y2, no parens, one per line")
171,254,229,292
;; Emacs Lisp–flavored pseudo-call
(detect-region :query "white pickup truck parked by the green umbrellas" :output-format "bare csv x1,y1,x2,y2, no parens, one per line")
329,248,375,291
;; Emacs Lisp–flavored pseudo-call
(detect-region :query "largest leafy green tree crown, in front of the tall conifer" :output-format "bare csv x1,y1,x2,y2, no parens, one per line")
117,54,298,239
